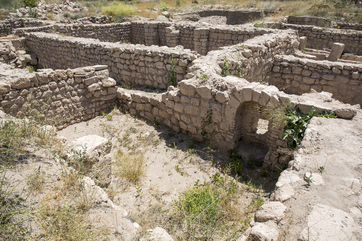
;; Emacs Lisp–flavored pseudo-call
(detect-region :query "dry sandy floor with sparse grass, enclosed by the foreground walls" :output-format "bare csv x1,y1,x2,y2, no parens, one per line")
1,110,268,240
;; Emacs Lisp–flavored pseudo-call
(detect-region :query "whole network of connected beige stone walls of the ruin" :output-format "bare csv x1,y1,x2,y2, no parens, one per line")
0,10,362,240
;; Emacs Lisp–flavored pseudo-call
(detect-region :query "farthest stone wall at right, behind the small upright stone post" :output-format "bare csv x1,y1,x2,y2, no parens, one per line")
274,23,362,55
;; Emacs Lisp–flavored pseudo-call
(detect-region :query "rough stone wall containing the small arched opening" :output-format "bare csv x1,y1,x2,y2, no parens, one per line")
117,80,287,156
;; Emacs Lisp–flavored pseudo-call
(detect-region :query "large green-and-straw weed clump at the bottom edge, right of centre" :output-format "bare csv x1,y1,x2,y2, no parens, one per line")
169,173,262,240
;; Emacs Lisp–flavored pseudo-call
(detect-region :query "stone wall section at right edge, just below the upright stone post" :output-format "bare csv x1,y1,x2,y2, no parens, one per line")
269,55,362,104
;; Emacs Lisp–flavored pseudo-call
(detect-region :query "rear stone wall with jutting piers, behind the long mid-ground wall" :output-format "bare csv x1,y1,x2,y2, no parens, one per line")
15,22,275,55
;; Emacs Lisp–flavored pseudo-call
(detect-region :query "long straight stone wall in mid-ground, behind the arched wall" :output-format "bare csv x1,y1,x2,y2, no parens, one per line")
26,33,197,89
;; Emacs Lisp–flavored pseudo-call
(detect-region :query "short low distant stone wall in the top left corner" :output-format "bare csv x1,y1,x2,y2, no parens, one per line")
0,18,49,35
